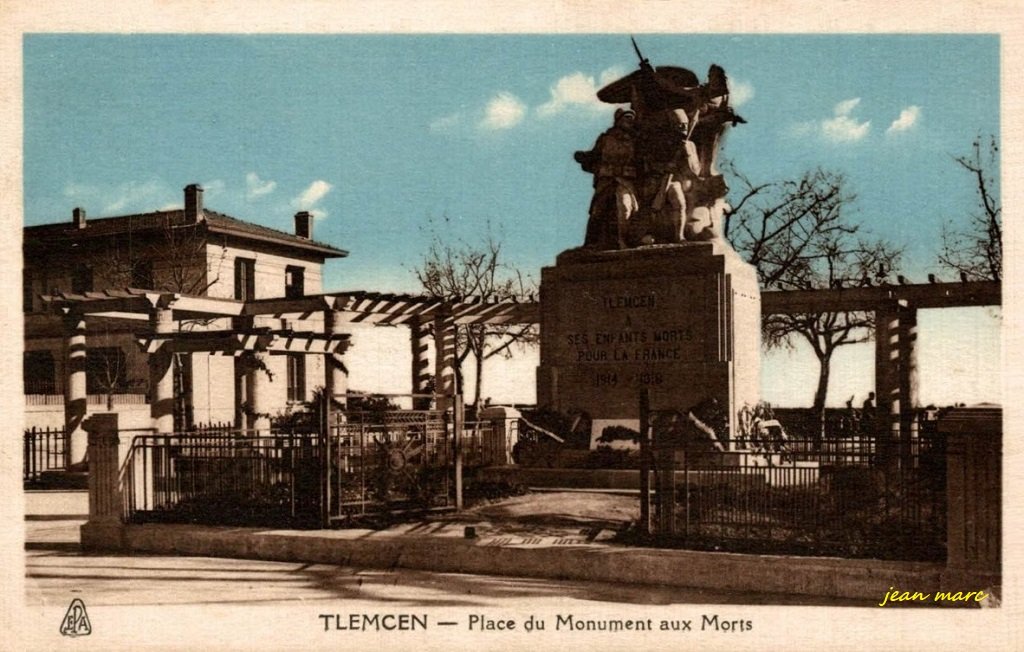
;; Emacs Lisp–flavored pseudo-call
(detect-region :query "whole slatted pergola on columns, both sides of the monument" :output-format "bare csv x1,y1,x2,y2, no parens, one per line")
43,281,1001,462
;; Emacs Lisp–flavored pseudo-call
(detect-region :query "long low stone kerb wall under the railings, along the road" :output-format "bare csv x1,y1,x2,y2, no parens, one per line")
103,525,943,603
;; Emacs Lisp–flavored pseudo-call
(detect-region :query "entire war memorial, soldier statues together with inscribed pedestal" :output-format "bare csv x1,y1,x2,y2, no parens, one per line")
538,43,761,445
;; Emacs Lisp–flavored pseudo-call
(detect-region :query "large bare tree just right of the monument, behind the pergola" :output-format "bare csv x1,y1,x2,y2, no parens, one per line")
723,164,902,433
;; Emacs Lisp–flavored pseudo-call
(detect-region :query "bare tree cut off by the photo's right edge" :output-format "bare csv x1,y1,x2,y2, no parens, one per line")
939,136,1002,280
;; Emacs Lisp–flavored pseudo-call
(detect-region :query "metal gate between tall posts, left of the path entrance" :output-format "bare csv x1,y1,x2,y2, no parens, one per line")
323,390,462,526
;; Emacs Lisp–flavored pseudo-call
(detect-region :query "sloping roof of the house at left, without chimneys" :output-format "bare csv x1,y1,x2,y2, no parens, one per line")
25,209,348,258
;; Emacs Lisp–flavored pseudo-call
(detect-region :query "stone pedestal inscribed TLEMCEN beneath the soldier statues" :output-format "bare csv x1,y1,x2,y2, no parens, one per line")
538,241,761,442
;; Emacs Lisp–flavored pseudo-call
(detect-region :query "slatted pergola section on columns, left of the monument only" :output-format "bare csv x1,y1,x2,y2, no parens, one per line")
43,288,539,461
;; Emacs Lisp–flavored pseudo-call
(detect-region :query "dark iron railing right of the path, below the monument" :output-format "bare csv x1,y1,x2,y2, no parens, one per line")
653,437,946,560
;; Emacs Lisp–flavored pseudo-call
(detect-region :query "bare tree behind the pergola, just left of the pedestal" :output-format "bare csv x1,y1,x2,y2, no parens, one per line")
414,218,537,407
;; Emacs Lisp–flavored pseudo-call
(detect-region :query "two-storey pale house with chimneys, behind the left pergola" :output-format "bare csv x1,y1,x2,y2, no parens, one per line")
23,185,347,429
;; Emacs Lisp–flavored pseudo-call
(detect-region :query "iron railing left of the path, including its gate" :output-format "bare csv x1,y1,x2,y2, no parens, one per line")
122,410,510,527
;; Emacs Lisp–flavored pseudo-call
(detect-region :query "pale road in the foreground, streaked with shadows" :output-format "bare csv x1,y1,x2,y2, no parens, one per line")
26,520,856,608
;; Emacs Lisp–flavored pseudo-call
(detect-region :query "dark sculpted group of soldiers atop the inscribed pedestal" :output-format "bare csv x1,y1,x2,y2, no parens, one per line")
574,50,745,249
